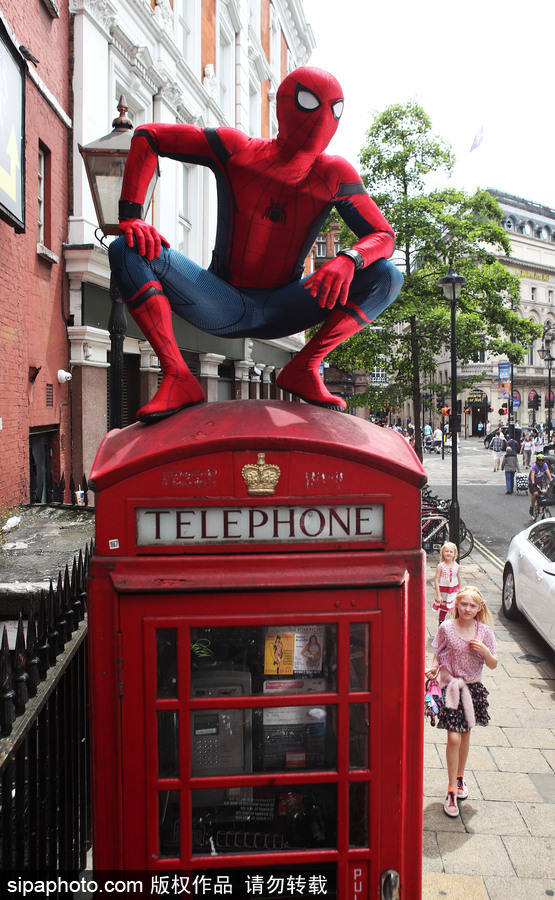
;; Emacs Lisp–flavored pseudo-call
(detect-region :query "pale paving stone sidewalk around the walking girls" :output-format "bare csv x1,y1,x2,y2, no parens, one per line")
422,553,555,900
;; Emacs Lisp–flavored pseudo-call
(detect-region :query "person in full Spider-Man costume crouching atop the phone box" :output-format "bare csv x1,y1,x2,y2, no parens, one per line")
110,67,402,422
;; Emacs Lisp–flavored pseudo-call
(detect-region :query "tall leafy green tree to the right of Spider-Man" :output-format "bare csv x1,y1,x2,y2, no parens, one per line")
330,101,541,457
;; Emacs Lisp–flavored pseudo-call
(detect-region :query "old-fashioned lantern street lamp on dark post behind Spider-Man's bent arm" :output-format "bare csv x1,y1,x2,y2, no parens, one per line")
78,95,159,428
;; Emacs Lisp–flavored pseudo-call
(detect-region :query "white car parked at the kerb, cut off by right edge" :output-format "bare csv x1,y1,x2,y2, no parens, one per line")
503,518,555,651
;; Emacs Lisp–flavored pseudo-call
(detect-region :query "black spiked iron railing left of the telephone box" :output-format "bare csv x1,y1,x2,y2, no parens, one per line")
0,547,91,872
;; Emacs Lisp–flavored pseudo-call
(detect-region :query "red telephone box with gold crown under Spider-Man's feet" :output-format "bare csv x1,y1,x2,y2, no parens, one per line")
89,401,425,900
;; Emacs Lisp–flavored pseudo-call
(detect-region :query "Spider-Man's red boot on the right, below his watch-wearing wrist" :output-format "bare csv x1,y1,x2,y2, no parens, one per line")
276,307,366,410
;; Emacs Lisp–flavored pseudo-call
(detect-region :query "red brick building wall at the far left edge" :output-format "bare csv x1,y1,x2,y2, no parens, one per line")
0,0,71,506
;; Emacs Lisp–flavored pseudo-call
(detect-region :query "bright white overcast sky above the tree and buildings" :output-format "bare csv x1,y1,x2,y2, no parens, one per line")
303,0,555,209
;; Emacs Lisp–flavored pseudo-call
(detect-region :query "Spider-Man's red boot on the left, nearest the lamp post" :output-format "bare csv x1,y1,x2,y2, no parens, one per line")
126,281,206,422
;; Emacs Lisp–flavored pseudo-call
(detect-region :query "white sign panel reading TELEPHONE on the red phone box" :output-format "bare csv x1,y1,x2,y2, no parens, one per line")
135,504,383,547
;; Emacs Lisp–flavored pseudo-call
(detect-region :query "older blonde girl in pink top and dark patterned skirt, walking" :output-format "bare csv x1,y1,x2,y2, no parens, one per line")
425,587,497,816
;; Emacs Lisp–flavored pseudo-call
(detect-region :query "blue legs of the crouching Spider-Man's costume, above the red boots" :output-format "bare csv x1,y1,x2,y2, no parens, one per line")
109,237,403,338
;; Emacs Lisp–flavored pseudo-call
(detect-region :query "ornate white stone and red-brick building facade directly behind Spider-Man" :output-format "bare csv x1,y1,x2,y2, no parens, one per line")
64,0,314,472
